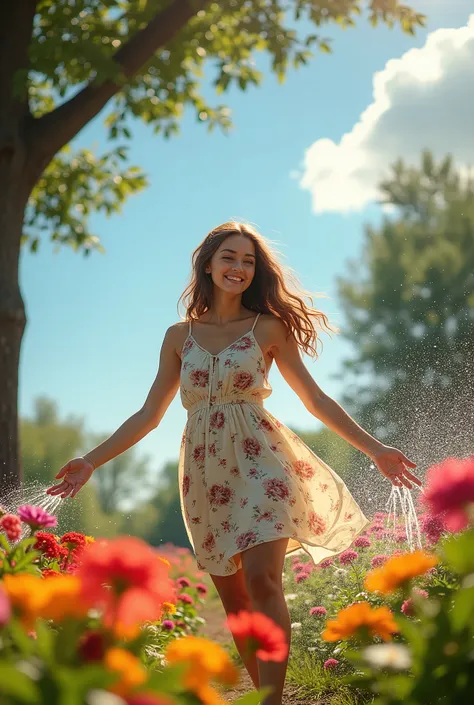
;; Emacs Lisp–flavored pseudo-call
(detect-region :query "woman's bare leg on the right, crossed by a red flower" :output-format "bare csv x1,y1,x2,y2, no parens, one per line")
242,538,291,705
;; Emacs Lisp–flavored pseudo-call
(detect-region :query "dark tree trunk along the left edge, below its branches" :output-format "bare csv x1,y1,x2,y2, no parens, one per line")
0,179,26,492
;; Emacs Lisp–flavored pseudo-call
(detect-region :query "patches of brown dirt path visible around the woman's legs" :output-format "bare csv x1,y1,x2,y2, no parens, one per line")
199,599,317,705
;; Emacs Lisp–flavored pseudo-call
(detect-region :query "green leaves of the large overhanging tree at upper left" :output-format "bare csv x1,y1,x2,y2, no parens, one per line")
20,0,424,254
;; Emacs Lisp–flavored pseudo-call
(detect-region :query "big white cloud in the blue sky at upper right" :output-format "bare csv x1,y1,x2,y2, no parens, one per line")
300,14,474,213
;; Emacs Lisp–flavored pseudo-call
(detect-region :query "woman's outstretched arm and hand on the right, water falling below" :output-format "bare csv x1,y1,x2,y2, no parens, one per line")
271,319,421,488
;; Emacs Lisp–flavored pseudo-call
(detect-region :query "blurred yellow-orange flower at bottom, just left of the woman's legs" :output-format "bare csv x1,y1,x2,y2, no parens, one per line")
165,636,239,693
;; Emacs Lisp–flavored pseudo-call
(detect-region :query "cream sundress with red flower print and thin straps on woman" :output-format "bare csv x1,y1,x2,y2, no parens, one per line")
178,314,369,575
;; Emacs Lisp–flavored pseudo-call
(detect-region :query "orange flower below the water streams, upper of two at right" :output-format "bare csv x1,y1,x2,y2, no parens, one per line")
365,551,438,595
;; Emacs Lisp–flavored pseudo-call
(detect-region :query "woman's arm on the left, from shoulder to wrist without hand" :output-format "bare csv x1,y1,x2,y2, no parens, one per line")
84,325,181,468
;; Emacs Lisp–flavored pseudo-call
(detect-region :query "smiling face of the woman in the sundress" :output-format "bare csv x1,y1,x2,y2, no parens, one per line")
206,235,256,294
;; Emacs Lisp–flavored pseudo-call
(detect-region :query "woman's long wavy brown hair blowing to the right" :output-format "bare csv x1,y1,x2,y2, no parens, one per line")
178,221,339,358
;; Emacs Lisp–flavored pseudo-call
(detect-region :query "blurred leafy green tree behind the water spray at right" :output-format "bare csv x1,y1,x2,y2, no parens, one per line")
338,152,474,464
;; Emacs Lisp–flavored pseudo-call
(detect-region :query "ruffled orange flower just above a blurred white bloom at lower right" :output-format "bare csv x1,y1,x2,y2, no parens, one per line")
322,602,399,641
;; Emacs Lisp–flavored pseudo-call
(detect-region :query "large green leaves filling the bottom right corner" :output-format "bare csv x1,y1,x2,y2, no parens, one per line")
347,529,474,705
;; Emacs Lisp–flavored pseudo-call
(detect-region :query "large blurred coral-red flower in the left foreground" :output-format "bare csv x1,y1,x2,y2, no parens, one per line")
76,536,175,636
